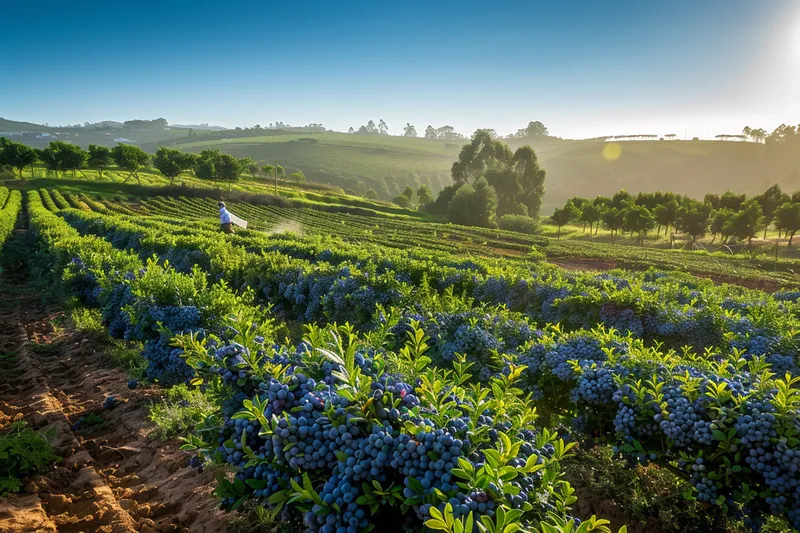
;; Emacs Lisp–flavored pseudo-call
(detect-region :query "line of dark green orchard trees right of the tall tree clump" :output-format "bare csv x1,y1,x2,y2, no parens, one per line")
550,185,800,246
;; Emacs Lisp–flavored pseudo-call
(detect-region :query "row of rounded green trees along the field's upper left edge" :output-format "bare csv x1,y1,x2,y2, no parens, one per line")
0,137,305,182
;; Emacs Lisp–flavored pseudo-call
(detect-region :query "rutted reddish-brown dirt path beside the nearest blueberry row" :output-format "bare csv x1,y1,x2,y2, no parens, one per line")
0,218,227,533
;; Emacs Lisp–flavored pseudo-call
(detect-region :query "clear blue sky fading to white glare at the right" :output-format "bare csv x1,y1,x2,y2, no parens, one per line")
0,0,800,138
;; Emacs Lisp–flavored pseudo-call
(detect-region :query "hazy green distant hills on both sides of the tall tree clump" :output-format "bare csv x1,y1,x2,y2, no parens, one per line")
0,119,800,209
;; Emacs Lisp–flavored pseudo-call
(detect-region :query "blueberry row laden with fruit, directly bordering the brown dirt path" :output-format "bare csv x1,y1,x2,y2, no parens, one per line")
29,191,620,533
